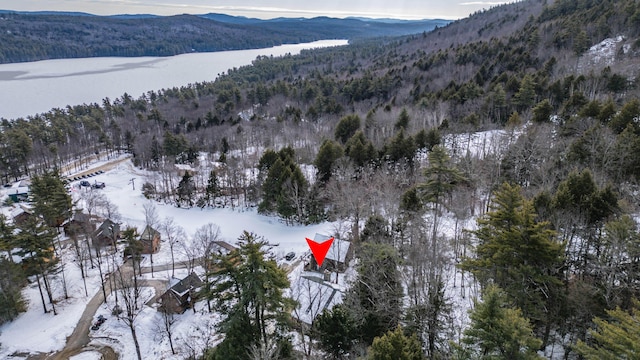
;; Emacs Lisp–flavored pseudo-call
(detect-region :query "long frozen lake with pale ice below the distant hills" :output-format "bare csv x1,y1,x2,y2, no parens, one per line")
0,40,347,119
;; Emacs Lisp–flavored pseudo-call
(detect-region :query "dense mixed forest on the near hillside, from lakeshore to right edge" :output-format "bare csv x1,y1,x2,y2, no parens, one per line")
0,0,640,359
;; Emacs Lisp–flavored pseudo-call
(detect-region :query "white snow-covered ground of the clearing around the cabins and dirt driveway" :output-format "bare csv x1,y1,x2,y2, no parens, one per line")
0,159,333,359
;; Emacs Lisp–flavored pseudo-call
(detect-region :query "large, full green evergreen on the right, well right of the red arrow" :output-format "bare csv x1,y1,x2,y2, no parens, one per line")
461,183,564,325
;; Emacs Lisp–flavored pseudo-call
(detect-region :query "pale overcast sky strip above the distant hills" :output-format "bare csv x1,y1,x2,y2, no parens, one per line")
0,0,513,19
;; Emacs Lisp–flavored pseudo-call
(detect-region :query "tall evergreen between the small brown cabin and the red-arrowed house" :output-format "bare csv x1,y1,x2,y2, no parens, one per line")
207,231,293,360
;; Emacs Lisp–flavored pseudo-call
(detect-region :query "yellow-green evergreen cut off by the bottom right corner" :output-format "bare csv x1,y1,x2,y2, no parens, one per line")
575,301,640,360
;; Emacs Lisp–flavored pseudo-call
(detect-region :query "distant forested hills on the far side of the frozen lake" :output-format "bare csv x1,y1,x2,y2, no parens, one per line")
0,12,448,63
